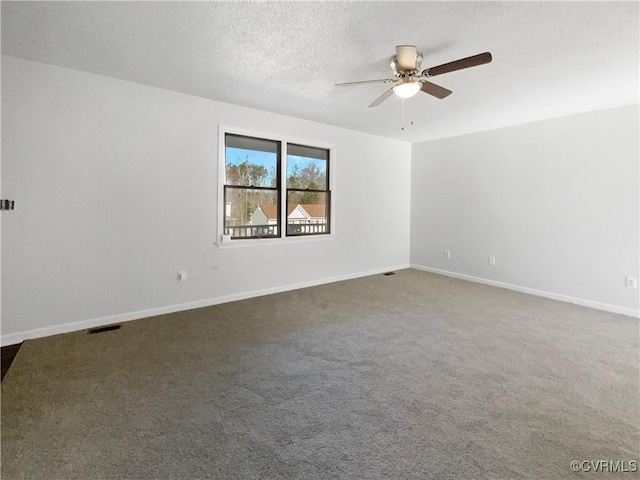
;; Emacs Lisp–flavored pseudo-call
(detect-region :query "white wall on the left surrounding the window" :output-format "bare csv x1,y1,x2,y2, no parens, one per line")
2,56,411,344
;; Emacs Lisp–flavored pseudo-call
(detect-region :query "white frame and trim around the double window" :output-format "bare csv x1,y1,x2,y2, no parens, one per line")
216,125,336,248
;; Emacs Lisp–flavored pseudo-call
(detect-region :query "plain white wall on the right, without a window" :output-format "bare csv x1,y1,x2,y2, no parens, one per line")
411,105,640,315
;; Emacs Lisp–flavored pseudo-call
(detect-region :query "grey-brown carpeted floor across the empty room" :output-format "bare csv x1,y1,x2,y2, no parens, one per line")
2,270,640,480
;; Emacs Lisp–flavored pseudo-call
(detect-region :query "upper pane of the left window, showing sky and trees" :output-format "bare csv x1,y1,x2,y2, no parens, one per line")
225,134,280,187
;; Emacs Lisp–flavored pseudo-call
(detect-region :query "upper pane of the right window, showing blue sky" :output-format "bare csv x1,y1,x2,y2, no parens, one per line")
287,145,329,190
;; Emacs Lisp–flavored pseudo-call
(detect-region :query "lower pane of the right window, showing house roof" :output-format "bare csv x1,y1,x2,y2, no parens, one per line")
287,190,329,235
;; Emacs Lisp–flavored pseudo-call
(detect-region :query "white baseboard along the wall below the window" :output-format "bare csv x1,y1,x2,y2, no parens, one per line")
0,264,409,347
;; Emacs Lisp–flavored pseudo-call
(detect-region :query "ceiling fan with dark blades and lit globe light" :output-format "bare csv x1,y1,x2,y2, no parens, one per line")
336,45,491,108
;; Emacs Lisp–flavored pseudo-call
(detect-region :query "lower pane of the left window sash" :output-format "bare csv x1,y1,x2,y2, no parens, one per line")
224,187,280,238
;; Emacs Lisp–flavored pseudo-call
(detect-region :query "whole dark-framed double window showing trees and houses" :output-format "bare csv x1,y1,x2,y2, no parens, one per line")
222,133,331,240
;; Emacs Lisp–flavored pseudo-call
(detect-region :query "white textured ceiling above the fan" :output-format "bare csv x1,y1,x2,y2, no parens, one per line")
2,1,640,142
